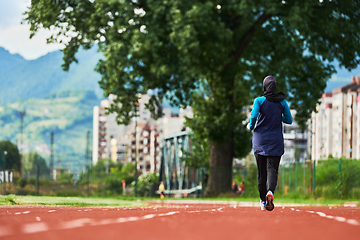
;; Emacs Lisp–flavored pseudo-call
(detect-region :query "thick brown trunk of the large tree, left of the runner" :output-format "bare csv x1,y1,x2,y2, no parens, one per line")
205,138,234,197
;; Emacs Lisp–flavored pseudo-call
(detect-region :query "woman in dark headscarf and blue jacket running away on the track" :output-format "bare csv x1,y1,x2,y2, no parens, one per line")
249,76,293,211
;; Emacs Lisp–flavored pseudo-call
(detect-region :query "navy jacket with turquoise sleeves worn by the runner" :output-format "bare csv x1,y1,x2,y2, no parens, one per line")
249,96,293,156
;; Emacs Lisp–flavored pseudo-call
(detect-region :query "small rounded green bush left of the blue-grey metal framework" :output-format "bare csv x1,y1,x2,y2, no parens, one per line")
131,173,159,197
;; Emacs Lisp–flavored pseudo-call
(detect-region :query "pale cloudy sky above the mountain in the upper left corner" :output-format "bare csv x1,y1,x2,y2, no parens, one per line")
0,0,63,60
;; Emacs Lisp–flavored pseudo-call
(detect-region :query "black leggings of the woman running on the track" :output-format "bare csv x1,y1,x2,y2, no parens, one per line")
255,154,281,201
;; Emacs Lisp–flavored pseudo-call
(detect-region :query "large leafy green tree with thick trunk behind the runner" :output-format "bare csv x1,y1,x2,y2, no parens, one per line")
25,0,360,194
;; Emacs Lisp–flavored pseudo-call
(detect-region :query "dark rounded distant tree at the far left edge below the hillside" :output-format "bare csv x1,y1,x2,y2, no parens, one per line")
0,141,20,171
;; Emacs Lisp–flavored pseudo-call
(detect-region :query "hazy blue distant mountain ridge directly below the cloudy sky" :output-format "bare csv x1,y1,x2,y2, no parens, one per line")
0,47,102,104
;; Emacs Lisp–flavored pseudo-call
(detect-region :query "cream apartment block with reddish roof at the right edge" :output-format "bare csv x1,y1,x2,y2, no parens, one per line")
311,76,360,160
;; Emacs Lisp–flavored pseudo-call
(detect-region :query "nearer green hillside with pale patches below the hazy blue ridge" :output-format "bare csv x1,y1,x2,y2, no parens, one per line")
0,90,99,167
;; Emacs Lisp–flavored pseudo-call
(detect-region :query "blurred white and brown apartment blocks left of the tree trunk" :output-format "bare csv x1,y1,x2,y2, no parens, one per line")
93,95,192,173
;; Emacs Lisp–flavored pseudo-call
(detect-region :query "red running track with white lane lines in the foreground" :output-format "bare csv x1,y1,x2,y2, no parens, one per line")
0,204,360,240
